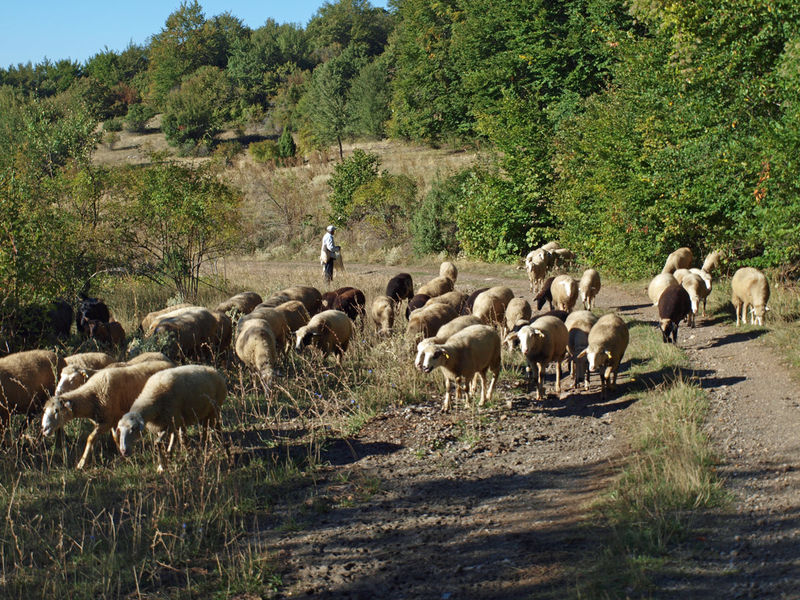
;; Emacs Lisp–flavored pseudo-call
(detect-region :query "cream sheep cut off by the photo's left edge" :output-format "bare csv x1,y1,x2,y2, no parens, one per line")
0,350,66,432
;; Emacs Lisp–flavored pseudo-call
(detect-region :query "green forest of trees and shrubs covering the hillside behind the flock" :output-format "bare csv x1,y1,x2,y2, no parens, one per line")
0,0,800,332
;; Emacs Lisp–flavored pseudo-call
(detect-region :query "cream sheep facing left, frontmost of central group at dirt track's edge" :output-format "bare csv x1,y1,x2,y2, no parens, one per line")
421,325,500,412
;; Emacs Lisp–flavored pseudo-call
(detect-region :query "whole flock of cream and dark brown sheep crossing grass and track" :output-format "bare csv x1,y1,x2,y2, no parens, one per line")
0,242,769,471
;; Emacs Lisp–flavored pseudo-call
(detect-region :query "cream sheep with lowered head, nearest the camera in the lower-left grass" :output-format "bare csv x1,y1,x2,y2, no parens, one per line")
115,365,228,473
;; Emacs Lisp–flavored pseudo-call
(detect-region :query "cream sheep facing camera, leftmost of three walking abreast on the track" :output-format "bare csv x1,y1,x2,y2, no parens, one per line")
507,317,569,400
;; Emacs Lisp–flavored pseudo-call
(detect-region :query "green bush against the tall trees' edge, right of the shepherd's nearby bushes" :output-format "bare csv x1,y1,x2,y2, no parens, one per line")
410,171,469,256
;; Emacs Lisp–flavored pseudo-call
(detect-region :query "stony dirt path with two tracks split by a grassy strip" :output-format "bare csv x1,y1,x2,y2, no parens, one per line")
266,265,800,600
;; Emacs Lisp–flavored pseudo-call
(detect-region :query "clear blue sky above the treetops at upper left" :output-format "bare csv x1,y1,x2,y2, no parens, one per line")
0,0,387,68
